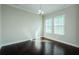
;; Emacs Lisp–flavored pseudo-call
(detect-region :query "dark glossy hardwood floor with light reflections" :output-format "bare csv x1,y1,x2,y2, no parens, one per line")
1,39,79,55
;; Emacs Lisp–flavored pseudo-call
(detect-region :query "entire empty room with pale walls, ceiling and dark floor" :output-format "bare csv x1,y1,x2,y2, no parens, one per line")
0,4,79,55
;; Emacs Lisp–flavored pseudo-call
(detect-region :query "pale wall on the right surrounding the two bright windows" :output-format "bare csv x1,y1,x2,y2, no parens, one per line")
44,5,79,47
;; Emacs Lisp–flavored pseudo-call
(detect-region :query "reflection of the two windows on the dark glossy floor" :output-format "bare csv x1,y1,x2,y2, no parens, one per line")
44,42,64,55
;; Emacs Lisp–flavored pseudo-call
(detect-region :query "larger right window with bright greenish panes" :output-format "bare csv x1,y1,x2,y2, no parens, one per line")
54,15,64,35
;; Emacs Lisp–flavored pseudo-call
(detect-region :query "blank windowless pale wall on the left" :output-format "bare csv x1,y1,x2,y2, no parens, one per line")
2,5,41,45
